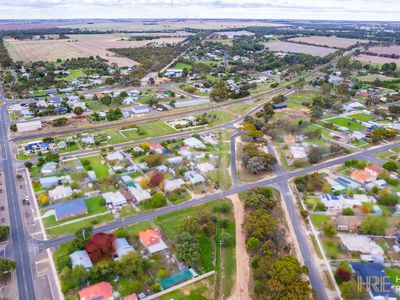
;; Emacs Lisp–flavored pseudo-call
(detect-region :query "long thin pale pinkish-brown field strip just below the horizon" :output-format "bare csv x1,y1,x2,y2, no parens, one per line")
57,20,282,32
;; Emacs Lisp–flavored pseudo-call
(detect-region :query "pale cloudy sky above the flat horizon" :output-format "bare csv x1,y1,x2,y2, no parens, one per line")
0,0,400,21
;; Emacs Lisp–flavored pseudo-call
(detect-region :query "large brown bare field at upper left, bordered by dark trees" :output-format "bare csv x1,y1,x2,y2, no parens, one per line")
5,34,184,67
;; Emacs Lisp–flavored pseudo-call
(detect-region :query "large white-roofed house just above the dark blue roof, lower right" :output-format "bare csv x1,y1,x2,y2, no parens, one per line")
338,234,384,255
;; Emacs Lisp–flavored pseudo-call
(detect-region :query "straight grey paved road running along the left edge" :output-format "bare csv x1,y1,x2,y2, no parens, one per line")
0,85,36,300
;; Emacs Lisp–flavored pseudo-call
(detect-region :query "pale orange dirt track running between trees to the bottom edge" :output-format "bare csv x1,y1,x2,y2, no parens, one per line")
228,194,251,300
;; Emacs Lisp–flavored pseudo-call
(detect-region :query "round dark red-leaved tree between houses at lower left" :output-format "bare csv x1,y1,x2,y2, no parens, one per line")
85,232,115,262
